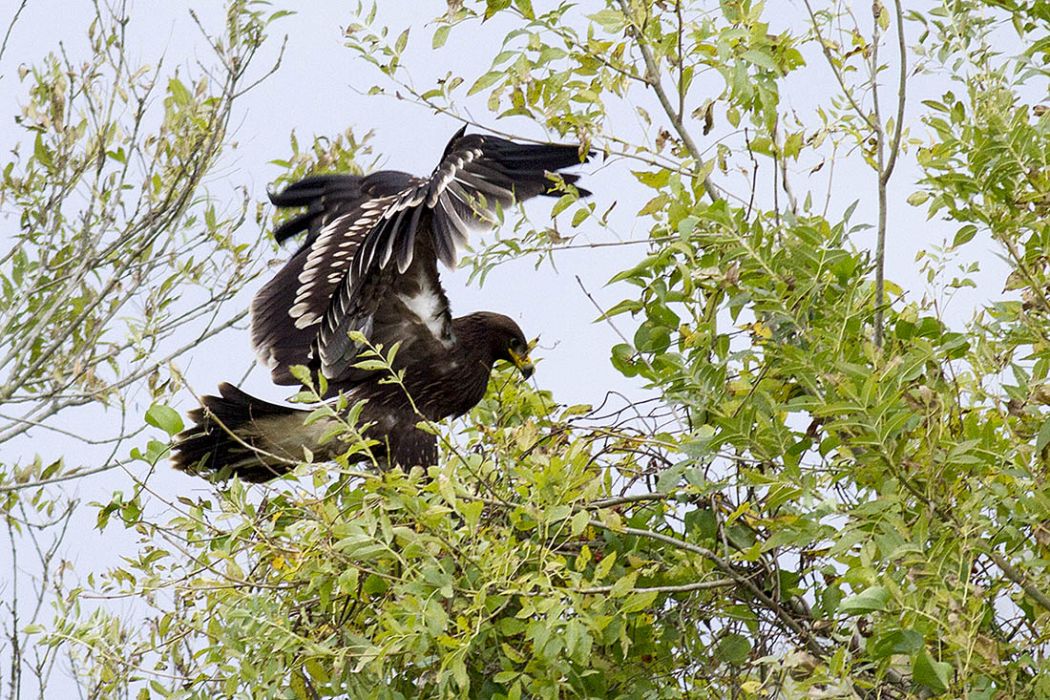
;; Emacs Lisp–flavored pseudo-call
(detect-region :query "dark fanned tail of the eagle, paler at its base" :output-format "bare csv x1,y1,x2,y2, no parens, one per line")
171,382,315,483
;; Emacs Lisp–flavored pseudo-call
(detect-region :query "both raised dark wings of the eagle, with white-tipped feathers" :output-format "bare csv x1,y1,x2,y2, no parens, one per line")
252,129,588,384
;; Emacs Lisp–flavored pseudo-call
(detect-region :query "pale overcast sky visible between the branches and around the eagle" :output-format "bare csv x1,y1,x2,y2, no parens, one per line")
0,0,1016,688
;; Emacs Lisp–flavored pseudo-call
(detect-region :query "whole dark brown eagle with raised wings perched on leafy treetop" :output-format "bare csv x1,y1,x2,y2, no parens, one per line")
172,127,589,483
